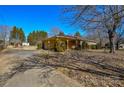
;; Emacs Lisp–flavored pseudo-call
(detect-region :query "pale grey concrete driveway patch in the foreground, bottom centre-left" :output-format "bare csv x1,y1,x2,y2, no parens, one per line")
4,67,81,87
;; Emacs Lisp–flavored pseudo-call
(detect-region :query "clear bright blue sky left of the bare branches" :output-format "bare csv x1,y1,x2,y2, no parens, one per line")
0,5,83,36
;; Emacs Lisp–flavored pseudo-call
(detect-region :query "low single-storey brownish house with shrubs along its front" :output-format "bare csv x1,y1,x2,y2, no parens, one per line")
42,36,96,51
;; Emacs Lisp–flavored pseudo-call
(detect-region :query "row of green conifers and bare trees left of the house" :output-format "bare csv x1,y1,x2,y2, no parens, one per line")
0,26,48,45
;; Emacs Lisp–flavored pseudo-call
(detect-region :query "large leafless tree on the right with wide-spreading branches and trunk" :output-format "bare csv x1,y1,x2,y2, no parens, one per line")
63,6,124,53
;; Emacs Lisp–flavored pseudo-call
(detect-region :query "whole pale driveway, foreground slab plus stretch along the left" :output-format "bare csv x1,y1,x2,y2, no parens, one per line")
0,47,81,87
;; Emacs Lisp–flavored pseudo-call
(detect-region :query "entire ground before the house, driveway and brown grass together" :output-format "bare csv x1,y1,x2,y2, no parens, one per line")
0,47,124,87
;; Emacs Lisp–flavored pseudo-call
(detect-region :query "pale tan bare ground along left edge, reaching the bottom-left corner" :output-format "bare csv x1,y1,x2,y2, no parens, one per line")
0,46,41,86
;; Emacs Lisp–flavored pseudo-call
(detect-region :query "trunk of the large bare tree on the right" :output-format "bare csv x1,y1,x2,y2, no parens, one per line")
108,31,115,53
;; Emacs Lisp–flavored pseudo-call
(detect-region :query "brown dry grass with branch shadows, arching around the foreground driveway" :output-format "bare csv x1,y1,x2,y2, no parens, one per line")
0,50,124,87
